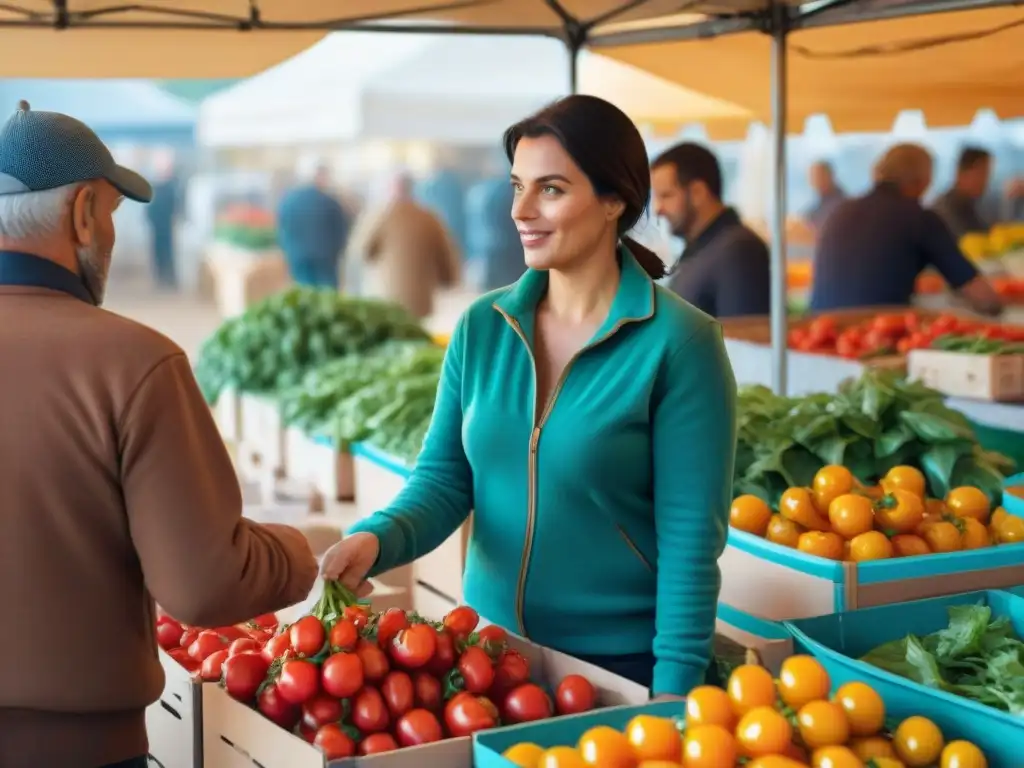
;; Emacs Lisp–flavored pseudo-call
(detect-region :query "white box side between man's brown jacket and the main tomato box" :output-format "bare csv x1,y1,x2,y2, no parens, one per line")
145,650,203,768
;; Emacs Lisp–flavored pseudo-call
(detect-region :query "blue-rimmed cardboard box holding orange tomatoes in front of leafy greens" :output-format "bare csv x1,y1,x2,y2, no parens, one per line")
718,528,1024,622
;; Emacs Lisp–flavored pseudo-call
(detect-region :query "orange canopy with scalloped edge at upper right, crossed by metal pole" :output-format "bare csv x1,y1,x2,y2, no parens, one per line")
597,7,1024,131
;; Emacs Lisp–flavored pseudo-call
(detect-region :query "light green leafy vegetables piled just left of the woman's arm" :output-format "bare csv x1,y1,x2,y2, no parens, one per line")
280,342,444,464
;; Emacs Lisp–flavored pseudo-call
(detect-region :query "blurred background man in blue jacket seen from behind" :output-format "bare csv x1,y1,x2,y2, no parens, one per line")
278,160,350,290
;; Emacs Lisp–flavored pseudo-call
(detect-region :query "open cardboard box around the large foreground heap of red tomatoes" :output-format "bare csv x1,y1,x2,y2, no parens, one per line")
203,637,649,768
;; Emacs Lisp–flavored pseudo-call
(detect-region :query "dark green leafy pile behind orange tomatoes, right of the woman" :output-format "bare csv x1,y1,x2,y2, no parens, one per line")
734,370,1013,509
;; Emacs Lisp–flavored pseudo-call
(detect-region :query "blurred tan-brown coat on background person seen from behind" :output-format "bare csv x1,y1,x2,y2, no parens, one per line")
347,200,460,317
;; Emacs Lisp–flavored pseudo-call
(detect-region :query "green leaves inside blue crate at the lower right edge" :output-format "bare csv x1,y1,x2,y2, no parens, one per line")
861,605,1024,716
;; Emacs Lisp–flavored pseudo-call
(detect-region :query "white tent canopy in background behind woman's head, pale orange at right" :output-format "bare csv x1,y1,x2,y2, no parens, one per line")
199,32,752,147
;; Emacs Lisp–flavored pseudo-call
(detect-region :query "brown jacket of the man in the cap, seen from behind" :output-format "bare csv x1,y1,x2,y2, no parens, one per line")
0,286,316,768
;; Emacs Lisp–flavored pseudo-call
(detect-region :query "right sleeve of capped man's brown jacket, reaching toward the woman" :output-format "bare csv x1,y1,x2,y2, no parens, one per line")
119,354,317,627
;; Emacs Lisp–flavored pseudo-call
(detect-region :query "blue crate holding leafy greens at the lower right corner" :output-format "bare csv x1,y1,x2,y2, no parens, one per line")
785,591,1024,768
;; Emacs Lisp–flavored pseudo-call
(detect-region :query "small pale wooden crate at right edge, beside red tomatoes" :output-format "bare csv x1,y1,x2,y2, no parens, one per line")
907,349,1024,402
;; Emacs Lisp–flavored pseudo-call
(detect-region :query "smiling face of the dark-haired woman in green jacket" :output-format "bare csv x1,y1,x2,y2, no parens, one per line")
512,136,624,270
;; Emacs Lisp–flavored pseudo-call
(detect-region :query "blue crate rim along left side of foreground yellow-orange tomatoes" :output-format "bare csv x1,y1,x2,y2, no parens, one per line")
473,701,686,768
